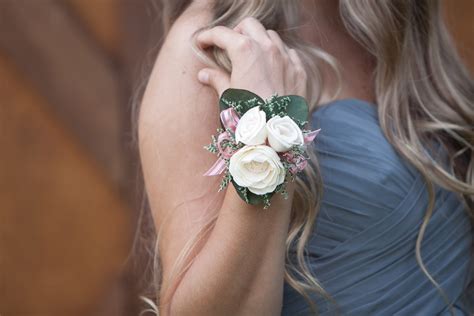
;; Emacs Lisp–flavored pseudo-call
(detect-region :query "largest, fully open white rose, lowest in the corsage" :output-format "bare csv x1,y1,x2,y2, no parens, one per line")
229,145,285,195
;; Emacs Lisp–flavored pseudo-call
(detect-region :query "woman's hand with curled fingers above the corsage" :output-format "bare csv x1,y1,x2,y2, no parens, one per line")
197,17,307,99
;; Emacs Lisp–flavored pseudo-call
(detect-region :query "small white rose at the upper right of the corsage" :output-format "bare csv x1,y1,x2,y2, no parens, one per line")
266,115,304,152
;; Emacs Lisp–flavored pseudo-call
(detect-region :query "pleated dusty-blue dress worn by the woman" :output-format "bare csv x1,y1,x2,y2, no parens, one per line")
282,99,474,316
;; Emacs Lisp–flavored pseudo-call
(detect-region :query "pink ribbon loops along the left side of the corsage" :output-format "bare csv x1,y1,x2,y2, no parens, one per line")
204,107,239,176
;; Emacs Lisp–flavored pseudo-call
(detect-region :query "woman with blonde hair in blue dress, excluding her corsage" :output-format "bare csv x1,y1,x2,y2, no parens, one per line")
134,0,474,315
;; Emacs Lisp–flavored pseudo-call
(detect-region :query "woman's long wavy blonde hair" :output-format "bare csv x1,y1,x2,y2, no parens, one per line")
133,0,474,313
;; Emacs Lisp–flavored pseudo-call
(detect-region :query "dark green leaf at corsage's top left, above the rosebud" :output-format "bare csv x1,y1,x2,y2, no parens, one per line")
219,88,265,115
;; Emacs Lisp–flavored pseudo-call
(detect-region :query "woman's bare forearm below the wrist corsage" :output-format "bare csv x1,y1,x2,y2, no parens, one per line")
165,183,294,315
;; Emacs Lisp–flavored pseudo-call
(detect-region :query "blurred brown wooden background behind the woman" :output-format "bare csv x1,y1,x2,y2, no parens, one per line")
0,0,474,316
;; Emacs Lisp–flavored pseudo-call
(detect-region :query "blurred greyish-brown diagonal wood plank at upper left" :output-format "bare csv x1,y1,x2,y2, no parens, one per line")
0,0,126,185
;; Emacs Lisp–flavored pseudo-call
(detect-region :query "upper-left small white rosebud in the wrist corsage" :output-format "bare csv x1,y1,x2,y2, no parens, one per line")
235,106,267,145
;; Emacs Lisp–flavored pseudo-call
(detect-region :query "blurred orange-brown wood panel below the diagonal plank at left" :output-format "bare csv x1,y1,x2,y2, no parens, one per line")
0,55,132,316
